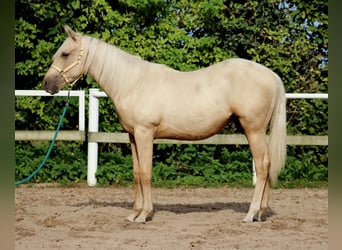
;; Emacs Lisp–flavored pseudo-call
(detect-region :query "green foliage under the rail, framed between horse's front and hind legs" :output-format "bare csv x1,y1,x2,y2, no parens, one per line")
153,145,252,185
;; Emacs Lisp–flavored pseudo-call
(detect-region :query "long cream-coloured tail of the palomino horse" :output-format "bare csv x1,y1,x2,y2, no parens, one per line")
269,75,286,184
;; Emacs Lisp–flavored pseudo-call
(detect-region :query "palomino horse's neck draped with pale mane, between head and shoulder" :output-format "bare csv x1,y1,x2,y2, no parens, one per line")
84,37,147,102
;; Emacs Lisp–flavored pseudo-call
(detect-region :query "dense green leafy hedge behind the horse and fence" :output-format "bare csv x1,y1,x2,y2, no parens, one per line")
15,0,328,185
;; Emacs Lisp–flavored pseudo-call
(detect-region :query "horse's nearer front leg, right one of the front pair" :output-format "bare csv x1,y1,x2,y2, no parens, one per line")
129,128,154,223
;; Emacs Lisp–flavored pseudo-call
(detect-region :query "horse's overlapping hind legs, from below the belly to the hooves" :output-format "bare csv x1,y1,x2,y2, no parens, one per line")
243,130,270,222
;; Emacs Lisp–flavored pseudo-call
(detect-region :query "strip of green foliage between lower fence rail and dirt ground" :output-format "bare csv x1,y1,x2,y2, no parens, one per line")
15,142,328,186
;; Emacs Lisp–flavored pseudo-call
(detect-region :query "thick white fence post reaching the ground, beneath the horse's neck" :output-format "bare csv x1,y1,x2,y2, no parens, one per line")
87,89,99,186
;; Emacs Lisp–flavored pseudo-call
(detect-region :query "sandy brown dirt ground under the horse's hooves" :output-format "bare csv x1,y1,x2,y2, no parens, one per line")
15,185,328,250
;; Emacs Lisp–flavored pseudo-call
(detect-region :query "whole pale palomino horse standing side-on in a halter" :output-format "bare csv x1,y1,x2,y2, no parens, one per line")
43,26,286,223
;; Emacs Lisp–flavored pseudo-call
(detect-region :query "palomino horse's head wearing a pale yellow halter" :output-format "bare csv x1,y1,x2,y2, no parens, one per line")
43,26,84,95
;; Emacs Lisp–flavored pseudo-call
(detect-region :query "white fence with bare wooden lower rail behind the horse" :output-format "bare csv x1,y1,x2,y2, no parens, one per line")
15,89,328,186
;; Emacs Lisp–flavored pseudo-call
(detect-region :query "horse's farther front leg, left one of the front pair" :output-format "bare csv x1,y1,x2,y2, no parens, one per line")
127,134,144,222
